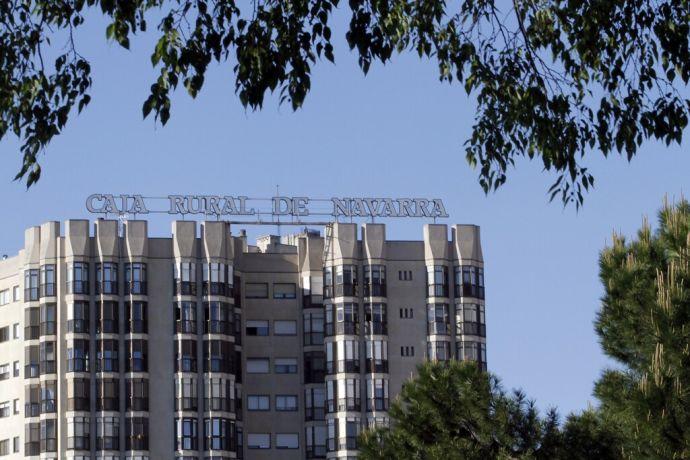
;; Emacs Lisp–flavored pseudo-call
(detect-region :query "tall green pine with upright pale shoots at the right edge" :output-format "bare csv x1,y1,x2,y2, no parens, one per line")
596,200,690,459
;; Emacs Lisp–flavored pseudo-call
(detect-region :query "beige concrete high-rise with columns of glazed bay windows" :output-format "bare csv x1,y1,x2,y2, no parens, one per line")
0,219,486,460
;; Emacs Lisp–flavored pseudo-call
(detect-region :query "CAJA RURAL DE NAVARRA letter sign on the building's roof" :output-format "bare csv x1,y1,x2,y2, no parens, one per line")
86,194,448,220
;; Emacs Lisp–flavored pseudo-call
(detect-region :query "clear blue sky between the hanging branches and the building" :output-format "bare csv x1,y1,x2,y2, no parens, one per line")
0,7,690,413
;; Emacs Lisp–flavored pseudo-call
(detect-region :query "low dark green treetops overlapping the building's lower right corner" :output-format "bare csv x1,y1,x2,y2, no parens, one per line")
359,362,621,460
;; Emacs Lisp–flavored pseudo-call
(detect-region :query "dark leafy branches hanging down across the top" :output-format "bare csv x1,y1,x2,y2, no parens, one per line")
0,0,690,206
